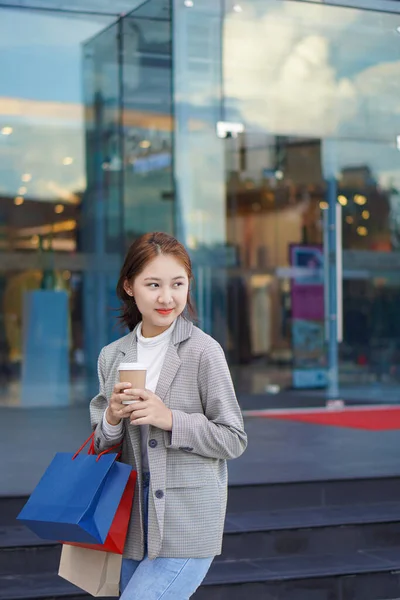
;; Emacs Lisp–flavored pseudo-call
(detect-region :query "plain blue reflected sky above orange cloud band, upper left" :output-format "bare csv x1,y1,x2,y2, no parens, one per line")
0,9,114,103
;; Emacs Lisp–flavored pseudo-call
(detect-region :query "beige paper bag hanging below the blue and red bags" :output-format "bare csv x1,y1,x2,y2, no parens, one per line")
58,544,122,596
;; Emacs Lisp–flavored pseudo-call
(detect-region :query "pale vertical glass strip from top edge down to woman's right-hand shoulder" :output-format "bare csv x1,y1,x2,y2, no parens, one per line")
173,0,228,344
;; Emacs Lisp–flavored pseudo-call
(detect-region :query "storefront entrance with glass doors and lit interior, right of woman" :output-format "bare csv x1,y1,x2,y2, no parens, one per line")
224,131,400,405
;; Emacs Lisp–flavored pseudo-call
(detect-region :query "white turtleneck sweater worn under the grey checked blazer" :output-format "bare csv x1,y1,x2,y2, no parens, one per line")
102,321,176,472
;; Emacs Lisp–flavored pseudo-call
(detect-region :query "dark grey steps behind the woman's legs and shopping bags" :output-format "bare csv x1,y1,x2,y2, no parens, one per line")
0,478,400,600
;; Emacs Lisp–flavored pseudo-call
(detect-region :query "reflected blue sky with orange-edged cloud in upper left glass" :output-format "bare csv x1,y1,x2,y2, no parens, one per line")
0,10,113,203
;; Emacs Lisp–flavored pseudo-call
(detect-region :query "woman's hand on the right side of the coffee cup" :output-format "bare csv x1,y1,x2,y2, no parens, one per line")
125,389,172,431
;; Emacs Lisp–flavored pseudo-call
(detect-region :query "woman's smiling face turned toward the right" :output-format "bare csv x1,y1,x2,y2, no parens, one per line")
124,254,189,337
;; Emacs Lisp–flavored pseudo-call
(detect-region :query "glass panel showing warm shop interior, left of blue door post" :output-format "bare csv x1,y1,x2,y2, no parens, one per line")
225,132,325,403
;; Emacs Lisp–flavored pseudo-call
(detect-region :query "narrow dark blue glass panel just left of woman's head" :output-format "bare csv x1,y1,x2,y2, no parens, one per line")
82,21,124,390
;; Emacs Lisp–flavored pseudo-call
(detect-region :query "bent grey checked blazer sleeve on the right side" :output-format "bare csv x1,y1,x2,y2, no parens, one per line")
167,340,247,459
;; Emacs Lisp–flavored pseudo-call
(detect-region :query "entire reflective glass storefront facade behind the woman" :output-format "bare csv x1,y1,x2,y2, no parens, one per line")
0,0,400,422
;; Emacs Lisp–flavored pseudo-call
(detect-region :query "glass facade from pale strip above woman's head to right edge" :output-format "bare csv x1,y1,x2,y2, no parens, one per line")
174,0,400,405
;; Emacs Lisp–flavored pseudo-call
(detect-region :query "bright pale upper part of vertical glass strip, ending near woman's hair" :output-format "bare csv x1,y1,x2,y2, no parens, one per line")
174,1,226,249
